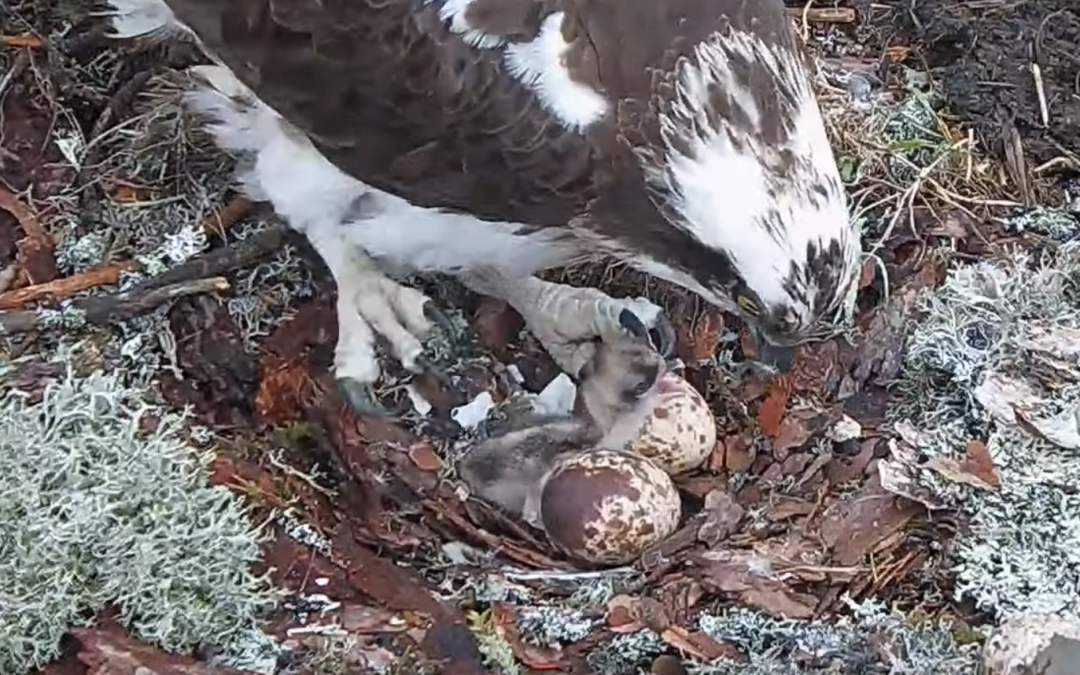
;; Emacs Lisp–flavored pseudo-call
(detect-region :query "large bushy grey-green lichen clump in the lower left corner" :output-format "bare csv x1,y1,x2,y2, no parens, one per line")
0,374,271,675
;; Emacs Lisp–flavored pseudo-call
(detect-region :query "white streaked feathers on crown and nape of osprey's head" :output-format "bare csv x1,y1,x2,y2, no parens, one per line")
645,31,858,319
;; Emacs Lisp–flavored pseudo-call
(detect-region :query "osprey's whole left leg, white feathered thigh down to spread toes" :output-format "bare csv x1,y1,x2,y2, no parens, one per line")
185,66,447,414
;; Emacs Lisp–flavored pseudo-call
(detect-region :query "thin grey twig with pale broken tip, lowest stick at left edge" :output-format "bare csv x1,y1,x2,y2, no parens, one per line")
0,276,229,335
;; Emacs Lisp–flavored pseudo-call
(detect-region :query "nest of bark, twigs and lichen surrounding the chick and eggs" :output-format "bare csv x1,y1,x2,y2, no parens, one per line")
0,0,1080,675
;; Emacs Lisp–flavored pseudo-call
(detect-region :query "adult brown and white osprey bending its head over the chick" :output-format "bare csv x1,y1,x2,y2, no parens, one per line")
101,0,860,410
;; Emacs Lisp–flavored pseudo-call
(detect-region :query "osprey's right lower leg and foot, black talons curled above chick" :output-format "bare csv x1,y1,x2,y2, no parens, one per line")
460,270,675,376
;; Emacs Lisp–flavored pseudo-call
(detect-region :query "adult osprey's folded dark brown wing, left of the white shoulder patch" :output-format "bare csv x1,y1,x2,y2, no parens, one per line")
159,0,592,226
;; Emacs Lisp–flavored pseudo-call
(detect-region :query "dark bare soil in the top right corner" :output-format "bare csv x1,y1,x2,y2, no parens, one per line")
870,0,1080,170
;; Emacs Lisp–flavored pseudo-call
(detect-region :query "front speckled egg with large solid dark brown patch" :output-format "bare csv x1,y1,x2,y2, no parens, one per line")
539,449,683,565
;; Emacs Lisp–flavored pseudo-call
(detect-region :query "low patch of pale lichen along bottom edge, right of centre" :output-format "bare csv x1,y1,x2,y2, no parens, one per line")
689,602,978,675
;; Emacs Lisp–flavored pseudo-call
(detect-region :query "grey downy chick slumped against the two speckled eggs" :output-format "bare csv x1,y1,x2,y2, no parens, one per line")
458,339,667,525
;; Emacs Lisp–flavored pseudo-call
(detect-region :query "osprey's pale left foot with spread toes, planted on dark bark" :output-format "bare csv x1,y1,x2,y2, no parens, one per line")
334,252,453,417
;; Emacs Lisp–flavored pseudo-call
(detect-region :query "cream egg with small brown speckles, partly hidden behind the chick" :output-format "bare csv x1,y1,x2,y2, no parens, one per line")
630,373,716,475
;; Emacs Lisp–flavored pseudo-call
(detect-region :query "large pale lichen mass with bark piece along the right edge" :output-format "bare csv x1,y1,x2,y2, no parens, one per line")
894,242,1080,620
